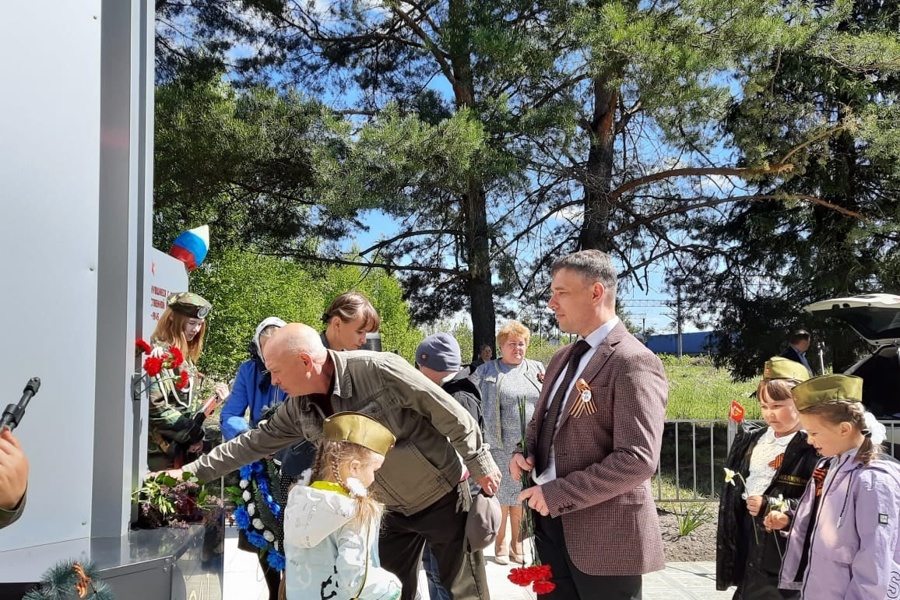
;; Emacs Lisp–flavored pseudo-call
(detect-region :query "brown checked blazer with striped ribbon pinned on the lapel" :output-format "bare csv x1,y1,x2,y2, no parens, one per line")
526,323,669,575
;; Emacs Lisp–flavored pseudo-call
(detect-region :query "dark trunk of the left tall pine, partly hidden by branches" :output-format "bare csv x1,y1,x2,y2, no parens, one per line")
445,0,496,359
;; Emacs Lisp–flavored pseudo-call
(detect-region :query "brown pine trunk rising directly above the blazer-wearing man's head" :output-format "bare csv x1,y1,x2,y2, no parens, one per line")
578,72,619,252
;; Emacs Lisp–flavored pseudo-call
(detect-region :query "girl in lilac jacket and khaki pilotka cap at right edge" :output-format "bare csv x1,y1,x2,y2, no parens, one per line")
766,375,900,600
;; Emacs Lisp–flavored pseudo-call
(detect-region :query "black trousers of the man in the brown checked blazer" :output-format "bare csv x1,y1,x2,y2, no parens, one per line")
531,511,643,600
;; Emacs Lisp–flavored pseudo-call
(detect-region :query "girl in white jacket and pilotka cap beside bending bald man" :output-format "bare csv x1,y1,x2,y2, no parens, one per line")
284,412,401,600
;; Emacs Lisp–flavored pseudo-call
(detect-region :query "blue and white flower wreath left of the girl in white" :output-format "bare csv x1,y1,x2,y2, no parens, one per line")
228,460,284,571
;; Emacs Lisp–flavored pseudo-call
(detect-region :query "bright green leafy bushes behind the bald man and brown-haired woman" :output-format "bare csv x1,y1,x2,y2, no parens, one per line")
191,250,421,380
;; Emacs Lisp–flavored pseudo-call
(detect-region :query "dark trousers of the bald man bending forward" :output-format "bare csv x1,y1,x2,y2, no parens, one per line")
378,483,490,600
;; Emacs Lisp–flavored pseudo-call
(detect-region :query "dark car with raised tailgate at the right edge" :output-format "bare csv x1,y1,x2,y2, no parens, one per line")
804,294,900,456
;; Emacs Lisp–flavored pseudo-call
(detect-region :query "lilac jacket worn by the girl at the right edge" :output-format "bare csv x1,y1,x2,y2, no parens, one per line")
779,449,900,600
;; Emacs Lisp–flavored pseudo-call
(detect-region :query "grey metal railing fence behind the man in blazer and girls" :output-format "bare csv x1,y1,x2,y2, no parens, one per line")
653,419,900,502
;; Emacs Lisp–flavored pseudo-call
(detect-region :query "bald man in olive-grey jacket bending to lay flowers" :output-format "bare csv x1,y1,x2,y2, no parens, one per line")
175,323,500,600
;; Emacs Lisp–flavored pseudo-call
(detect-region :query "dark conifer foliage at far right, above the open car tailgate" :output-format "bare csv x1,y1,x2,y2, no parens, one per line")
682,1,900,379
